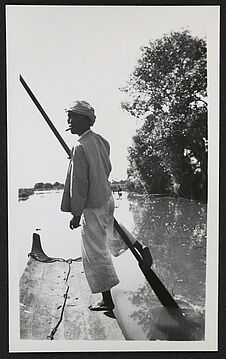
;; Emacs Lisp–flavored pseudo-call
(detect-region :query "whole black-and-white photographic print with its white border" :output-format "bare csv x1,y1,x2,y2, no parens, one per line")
5,5,220,352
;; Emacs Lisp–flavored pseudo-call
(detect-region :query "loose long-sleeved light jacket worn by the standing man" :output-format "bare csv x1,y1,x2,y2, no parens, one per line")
61,130,111,216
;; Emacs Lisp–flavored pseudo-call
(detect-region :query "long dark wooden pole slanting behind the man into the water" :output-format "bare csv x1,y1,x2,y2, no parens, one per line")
20,75,182,309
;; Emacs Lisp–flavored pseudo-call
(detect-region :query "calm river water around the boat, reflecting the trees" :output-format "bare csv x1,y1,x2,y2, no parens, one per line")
17,191,207,340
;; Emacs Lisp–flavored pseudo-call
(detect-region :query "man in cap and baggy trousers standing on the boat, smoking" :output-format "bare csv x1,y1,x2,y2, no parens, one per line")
61,101,122,311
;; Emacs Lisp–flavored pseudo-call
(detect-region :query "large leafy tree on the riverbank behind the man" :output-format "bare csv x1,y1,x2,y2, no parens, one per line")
122,31,207,199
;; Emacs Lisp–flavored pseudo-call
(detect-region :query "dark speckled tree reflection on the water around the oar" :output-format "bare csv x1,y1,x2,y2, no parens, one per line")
123,197,207,340
